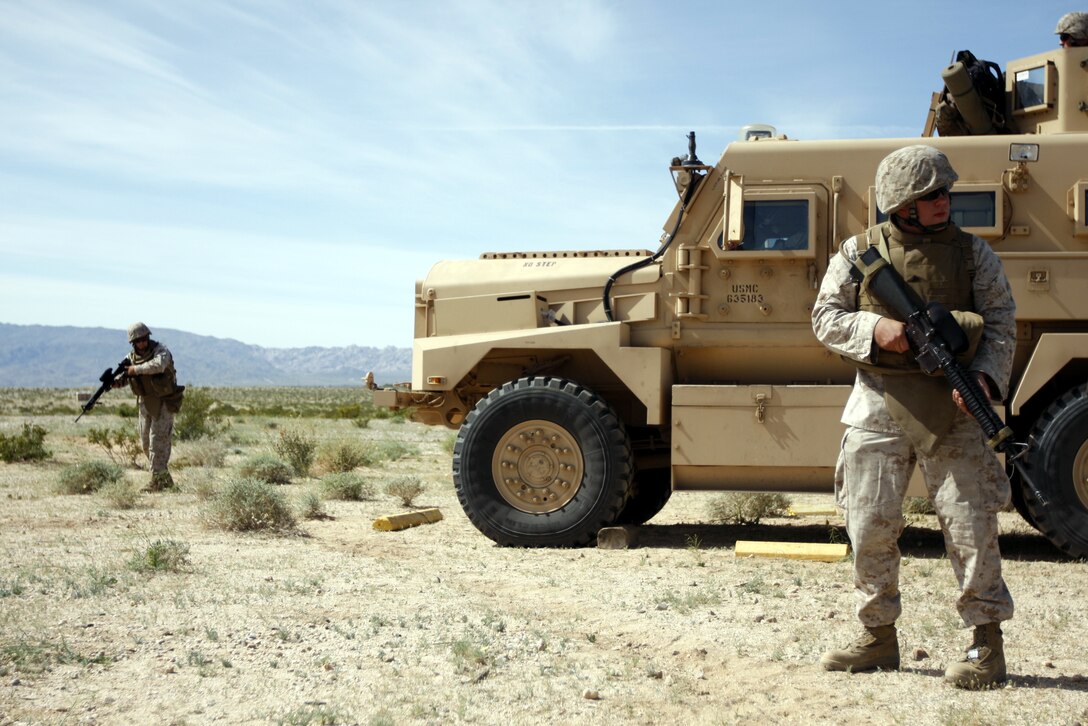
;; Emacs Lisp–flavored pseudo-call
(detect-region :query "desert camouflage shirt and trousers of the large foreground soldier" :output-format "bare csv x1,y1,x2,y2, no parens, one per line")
813,228,1015,627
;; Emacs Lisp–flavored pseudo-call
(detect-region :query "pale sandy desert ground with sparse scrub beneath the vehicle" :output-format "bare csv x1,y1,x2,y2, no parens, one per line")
0,390,1088,726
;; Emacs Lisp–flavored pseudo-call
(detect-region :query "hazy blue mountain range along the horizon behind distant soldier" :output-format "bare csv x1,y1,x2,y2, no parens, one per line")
0,323,411,387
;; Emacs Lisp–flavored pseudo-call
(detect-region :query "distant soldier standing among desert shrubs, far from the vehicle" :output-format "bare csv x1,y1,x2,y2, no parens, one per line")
119,322,185,491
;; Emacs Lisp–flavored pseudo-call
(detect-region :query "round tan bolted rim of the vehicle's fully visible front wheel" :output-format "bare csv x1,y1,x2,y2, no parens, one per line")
491,420,583,514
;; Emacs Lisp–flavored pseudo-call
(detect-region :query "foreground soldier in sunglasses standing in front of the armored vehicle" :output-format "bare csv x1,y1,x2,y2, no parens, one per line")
813,145,1015,688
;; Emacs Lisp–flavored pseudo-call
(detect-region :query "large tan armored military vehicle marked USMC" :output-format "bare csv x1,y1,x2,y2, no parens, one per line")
374,48,1088,557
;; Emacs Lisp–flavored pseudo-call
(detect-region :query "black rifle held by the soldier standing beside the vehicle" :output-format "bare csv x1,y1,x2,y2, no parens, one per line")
850,247,1047,506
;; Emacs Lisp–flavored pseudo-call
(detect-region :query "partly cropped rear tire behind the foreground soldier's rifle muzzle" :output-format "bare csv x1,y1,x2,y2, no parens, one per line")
1024,385,1088,557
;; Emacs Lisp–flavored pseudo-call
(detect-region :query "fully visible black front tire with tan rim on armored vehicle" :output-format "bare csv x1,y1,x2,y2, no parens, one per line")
454,377,632,546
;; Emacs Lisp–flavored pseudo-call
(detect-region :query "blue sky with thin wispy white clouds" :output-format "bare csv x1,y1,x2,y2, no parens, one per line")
0,0,1081,347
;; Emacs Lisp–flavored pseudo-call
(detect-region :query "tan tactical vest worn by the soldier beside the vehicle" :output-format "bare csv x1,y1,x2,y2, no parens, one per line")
855,221,980,455
